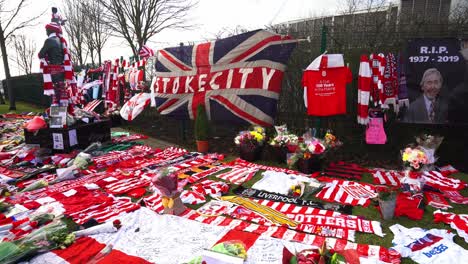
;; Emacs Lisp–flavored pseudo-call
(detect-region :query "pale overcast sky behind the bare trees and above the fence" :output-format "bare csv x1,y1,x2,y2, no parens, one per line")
0,0,352,79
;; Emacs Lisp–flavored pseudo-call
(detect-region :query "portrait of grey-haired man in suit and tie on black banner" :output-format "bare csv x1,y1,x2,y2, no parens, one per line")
404,68,448,124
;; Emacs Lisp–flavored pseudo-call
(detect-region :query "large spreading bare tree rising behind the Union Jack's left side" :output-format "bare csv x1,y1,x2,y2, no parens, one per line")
97,0,196,57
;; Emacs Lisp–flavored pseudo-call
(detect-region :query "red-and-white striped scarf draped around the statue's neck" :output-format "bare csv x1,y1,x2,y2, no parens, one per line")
40,33,73,95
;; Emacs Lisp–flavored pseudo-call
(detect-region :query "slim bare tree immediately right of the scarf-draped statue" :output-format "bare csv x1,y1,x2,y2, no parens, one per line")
64,0,88,66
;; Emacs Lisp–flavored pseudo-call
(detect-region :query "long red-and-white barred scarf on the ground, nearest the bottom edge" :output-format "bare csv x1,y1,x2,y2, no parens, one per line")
180,209,400,263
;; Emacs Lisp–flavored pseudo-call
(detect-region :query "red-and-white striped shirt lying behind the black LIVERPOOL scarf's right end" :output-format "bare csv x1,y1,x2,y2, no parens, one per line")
315,180,377,207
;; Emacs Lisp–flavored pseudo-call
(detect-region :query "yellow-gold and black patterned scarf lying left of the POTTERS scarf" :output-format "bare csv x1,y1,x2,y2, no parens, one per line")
221,196,299,227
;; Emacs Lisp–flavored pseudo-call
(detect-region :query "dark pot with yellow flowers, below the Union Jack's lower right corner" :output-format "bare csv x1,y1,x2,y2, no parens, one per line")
234,127,265,161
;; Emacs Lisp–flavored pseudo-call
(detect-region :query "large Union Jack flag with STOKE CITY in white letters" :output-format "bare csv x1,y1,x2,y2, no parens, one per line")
152,30,297,126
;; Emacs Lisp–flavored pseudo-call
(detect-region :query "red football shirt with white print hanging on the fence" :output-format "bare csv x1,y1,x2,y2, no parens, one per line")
302,67,353,116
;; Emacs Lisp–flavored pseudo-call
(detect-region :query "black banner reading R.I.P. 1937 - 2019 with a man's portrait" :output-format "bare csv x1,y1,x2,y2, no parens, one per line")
401,39,468,124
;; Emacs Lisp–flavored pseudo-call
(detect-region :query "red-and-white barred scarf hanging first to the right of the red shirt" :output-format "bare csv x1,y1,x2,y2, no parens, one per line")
357,55,372,125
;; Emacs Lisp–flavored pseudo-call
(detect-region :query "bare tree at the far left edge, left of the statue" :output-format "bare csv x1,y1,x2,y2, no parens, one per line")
0,0,45,110
